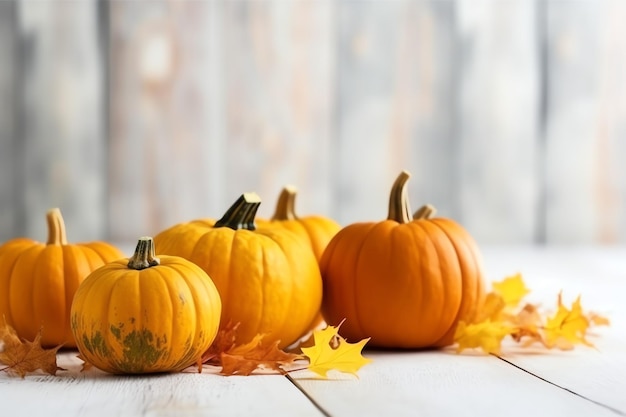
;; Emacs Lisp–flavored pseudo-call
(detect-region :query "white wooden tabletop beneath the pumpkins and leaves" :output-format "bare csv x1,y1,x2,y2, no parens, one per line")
0,248,626,417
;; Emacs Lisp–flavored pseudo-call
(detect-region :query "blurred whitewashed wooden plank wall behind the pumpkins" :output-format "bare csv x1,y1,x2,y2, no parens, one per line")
0,0,626,244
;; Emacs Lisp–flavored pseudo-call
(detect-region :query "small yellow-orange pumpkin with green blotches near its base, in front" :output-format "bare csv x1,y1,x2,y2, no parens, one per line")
71,237,221,374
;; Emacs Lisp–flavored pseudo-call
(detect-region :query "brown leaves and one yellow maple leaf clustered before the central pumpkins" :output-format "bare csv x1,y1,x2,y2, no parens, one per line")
198,318,371,378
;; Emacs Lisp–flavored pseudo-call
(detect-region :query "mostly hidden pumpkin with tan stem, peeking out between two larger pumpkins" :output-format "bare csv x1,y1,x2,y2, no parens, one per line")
271,185,341,261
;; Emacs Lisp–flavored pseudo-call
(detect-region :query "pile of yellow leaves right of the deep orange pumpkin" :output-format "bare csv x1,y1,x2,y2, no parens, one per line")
454,274,609,355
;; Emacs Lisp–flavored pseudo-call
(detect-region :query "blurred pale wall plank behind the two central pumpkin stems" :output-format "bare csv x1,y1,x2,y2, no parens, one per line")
221,1,340,221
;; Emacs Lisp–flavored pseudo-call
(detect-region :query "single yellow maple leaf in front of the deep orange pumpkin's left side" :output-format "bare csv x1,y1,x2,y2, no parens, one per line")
302,324,372,378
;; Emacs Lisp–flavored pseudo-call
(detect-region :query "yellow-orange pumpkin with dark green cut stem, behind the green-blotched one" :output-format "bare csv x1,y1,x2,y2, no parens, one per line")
154,193,322,347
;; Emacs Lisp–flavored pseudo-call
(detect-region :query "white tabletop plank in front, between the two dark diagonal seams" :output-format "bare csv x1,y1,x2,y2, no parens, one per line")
298,352,615,417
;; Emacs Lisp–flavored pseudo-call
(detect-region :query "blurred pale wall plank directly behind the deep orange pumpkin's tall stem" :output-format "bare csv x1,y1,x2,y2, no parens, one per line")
334,1,459,223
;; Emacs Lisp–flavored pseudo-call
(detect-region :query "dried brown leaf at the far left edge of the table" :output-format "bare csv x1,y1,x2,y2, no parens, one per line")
0,322,62,378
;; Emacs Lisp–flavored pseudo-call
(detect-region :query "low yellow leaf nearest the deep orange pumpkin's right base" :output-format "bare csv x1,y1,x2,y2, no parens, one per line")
454,320,515,355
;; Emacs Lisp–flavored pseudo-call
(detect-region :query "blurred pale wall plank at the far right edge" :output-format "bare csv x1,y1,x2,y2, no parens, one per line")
546,1,626,243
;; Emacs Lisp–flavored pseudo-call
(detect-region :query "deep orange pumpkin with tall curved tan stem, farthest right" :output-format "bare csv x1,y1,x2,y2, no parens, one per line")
320,171,484,348
